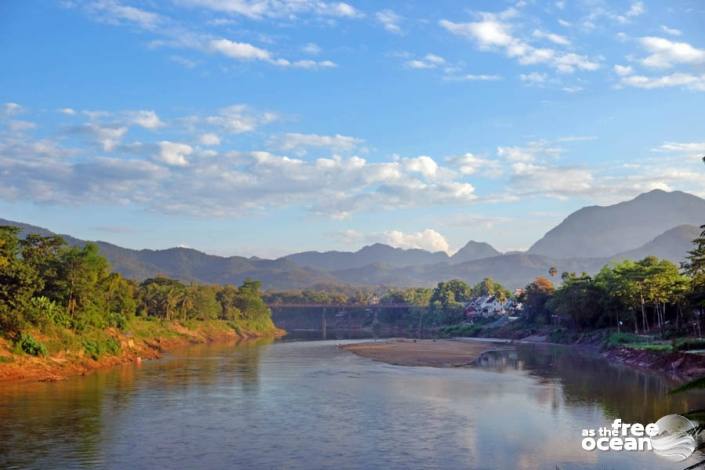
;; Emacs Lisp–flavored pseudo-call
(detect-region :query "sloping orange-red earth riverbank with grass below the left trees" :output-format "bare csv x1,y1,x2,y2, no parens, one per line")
0,319,285,383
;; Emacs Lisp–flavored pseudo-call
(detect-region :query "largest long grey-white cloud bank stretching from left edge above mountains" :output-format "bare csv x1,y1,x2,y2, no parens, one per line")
0,106,477,218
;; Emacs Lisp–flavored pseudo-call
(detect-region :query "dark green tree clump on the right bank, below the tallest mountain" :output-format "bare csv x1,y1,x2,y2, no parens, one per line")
522,225,705,336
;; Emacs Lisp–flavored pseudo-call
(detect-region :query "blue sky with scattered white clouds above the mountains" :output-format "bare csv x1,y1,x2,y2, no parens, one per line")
0,0,705,257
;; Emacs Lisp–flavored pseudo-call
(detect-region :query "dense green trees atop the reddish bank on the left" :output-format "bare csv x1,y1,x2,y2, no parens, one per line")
0,226,273,356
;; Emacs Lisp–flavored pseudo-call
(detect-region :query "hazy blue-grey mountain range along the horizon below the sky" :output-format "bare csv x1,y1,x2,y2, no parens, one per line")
5,190,705,289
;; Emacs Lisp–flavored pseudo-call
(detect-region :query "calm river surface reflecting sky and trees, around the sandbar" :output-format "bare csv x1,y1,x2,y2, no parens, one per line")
0,340,705,470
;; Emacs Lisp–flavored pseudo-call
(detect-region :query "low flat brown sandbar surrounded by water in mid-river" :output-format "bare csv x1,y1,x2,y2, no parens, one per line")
340,339,508,367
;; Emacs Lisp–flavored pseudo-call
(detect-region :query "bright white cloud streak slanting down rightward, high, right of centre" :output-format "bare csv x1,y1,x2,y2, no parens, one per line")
439,9,600,73
